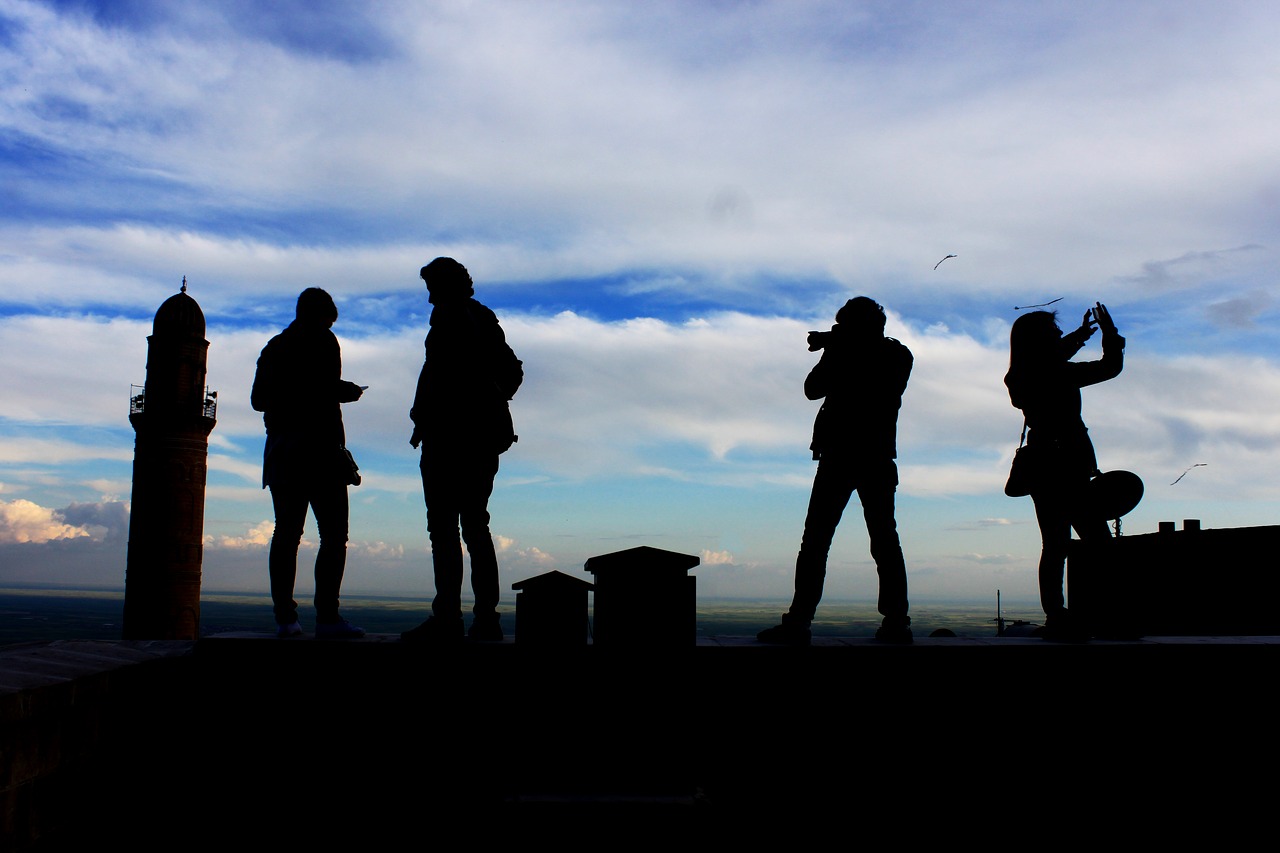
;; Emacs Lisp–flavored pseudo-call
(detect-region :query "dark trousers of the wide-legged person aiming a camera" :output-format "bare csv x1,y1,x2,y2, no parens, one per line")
783,453,910,628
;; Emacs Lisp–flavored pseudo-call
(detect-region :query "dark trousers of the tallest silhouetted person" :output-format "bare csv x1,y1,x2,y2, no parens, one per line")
421,448,498,620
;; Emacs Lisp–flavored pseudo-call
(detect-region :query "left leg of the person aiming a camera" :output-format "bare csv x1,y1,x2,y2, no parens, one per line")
782,457,854,628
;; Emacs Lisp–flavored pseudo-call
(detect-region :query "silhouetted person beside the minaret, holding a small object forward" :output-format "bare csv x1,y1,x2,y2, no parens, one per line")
251,287,365,639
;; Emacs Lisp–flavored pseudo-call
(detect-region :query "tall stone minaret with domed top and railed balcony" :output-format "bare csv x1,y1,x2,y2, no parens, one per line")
124,278,218,639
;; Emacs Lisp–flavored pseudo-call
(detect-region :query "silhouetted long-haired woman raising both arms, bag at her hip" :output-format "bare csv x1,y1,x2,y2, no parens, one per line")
1005,302,1124,640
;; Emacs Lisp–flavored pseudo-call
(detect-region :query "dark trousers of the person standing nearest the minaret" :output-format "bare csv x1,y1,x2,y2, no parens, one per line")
268,483,348,625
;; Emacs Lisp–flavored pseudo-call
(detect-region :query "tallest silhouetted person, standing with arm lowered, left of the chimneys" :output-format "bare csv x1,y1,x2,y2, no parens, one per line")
401,257,524,643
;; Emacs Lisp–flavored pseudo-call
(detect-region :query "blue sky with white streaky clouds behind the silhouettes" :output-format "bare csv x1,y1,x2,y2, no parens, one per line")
0,0,1280,612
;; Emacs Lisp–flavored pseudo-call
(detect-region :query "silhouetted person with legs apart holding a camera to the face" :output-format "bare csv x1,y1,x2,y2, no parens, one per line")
756,296,913,646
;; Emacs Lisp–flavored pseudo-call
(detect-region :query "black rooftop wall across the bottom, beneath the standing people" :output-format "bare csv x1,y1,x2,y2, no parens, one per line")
0,635,1280,850
